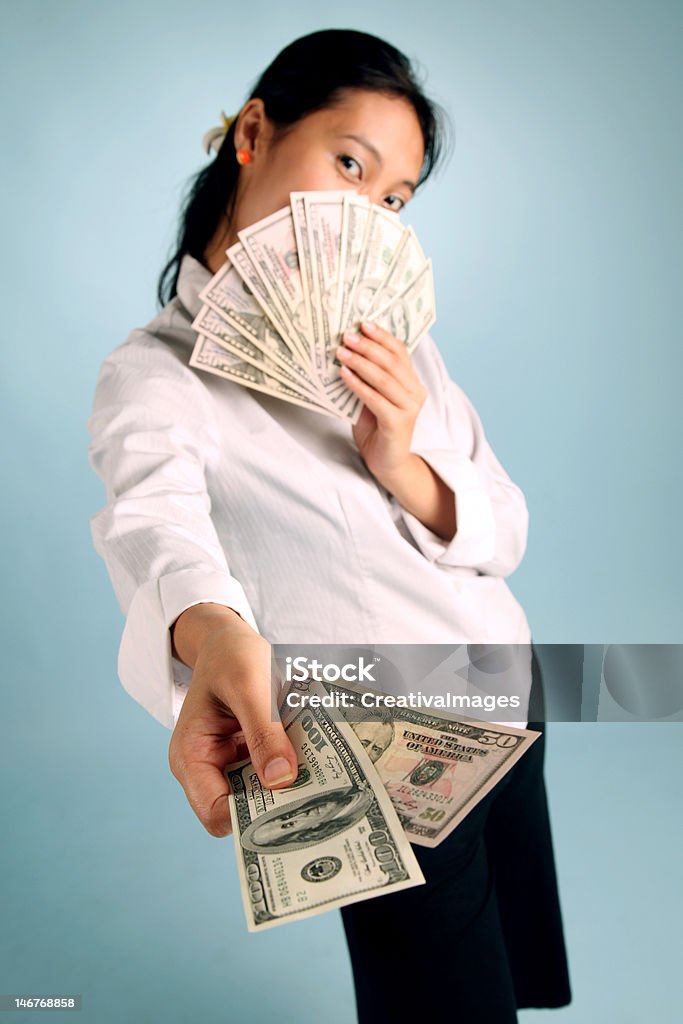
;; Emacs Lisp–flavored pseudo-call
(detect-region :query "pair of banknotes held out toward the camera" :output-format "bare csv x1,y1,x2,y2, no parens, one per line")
225,681,540,932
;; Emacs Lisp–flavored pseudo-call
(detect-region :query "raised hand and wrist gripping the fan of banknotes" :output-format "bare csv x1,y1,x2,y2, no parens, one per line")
337,322,427,490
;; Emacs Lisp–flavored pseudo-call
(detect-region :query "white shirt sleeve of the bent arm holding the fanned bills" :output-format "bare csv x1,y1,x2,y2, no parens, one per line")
401,337,528,577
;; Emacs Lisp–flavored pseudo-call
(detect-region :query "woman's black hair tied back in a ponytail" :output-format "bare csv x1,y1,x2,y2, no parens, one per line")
157,29,447,305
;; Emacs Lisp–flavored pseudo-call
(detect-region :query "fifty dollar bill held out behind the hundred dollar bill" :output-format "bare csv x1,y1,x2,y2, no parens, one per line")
282,680,541,847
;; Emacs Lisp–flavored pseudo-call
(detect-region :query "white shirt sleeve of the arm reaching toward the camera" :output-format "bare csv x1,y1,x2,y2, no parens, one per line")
88,338,257,728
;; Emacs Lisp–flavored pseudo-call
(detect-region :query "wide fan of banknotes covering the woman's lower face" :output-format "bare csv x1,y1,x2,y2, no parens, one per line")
190,190,435,423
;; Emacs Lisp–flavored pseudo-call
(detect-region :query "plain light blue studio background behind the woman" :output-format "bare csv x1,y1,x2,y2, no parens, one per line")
0,0,683,1024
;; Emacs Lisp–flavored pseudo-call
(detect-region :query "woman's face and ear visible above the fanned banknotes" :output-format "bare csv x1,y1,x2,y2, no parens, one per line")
207,90,424,271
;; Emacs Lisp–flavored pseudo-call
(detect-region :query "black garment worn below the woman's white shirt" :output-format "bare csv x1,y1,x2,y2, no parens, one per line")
341,649,571,1024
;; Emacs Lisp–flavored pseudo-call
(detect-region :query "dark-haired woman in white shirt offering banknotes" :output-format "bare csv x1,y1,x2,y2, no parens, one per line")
90,30,569,1024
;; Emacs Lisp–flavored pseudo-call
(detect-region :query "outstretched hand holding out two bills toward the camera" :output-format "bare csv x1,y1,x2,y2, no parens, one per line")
169,604,297,837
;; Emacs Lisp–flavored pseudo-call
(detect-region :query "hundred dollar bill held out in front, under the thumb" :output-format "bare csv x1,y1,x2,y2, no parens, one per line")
225,691,424,932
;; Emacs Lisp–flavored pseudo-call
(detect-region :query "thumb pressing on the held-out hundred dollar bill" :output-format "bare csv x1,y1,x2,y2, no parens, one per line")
232,687,298,788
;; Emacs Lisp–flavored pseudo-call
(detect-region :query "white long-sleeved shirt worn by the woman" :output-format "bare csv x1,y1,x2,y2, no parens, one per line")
88,256,530,728
